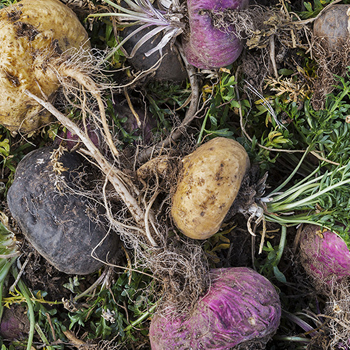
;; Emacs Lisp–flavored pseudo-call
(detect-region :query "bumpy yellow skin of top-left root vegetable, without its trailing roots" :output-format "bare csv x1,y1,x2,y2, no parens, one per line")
0,0,90,133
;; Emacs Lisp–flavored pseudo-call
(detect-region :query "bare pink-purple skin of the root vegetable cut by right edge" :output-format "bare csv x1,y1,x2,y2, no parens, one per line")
300,225,350,285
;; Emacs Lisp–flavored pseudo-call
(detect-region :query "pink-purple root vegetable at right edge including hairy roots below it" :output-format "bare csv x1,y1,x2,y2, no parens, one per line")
300,225,350,349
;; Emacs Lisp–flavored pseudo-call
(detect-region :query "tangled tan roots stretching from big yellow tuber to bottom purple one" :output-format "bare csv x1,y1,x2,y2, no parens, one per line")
26,45,209,312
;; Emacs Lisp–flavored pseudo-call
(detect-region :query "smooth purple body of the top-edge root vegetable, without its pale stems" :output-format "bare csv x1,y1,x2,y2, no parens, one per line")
183,0,249,69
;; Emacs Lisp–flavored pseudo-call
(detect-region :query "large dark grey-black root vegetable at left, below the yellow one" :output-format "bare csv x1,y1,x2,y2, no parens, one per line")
7,147,119,275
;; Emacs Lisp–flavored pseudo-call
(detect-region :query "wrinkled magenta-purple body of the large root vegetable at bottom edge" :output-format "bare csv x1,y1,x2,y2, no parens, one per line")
149,267,281,350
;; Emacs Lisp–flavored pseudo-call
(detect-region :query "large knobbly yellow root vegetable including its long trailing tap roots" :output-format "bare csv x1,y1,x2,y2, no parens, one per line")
0,0,148,243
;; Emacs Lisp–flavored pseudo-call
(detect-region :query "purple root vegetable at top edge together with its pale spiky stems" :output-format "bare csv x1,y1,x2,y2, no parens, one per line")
91,0,249,69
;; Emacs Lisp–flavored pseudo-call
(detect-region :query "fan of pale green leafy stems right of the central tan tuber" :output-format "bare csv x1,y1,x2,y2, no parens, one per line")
260,158,350,230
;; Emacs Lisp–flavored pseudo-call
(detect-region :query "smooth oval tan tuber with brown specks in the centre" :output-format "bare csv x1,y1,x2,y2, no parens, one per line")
171,137,250,239
